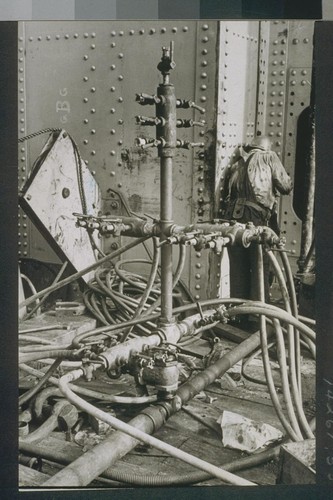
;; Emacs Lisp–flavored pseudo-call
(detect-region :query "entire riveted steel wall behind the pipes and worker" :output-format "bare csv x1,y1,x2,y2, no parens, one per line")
18,21,313,299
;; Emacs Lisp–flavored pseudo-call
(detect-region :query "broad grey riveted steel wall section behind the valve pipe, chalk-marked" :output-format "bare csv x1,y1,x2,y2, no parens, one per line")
19,21,218,299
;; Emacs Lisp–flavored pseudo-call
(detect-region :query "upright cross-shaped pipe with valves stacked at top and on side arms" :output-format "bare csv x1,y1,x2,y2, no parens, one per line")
76,42,281,325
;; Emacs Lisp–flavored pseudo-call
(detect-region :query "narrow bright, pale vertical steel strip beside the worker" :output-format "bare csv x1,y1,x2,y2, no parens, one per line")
213,21,259,296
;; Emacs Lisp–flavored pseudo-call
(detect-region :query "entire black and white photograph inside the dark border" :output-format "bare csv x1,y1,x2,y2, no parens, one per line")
11,20,322,494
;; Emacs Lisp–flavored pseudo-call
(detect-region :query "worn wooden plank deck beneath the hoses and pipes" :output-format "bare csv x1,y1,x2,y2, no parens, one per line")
19,312,314,488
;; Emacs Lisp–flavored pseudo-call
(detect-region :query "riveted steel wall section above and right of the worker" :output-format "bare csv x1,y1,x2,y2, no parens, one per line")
257,21,314,270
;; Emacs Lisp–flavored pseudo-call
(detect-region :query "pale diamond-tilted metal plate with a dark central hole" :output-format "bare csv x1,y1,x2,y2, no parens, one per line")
23,132,101,281
